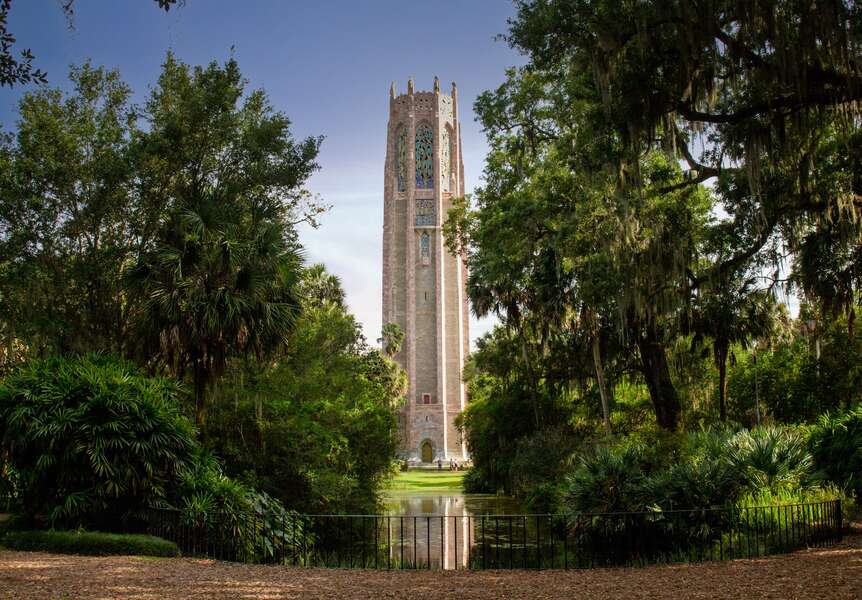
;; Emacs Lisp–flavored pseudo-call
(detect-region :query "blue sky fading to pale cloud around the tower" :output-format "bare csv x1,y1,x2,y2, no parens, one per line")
0,0,524,343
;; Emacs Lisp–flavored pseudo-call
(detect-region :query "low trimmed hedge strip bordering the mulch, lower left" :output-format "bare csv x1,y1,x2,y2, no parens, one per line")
0,531,180,557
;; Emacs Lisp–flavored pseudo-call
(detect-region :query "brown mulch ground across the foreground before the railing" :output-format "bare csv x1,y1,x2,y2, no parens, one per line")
0,534,862,600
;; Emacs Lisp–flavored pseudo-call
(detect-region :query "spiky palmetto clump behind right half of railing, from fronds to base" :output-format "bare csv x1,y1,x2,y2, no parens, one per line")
562,428,816,564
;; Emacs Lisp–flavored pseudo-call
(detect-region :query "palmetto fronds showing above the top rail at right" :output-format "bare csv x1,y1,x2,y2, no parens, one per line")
562,428,816,514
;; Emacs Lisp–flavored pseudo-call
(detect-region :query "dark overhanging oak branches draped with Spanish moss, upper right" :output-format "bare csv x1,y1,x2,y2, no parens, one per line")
507,0,862,316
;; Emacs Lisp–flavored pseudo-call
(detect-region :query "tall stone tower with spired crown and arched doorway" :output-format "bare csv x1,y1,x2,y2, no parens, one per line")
383,77,469,463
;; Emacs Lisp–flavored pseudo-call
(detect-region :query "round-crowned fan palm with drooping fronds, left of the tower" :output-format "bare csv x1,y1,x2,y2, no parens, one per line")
128,199,301,425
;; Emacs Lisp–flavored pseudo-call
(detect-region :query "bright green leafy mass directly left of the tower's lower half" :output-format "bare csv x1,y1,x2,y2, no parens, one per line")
207,271,406,513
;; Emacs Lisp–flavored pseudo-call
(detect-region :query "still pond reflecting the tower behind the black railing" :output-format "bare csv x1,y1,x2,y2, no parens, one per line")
384,482,523,569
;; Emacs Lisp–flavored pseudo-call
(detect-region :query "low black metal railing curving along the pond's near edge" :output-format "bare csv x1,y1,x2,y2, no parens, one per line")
147,500,843,569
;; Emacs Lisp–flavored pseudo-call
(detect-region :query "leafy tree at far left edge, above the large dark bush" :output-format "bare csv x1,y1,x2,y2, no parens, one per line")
0,63,137,356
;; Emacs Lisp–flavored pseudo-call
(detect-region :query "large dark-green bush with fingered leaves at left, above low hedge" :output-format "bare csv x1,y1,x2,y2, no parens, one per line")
0,355,296,553
